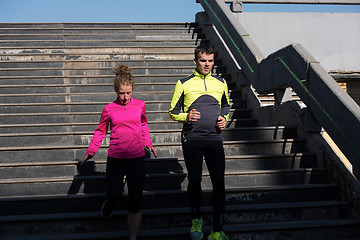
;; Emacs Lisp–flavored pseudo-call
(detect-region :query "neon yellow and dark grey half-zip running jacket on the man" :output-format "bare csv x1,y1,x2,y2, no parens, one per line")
169,70,230,140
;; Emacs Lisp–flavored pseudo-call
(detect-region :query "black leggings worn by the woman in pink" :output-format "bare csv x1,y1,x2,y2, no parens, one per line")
105,156,145,213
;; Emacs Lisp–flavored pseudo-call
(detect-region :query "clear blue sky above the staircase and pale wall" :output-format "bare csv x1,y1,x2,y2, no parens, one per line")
0,0,360,23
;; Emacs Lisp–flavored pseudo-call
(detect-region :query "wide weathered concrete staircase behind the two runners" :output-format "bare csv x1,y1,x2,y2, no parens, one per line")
0,23,360,240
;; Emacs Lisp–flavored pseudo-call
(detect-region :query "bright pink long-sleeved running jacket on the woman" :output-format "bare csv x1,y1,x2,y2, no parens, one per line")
86,98,152,159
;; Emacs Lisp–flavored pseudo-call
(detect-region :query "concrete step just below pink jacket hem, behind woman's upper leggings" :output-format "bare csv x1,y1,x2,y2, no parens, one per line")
0,153,317,179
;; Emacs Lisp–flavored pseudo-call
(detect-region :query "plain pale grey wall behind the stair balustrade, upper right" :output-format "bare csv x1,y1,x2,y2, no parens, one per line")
234,12,360,72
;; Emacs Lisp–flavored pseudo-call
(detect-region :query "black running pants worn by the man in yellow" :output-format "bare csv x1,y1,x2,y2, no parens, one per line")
182,140,225,232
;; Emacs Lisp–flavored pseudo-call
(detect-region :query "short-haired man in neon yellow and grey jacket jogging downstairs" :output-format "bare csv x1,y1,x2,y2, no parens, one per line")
169,45,230,240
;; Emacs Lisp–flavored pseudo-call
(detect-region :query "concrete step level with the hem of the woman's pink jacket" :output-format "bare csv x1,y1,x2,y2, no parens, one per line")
0,139,306,163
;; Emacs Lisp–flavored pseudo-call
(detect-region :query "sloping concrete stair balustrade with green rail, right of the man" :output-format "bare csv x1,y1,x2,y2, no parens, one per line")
197,0,360,173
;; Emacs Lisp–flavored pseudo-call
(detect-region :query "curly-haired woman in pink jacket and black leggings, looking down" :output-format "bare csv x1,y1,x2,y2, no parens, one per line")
81,65,157,240
